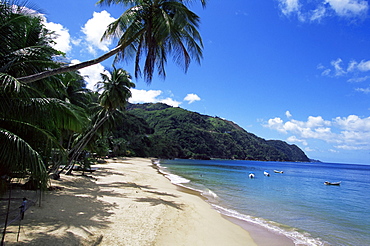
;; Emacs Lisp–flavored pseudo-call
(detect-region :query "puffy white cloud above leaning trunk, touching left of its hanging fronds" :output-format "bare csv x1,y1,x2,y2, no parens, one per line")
81,10,115,55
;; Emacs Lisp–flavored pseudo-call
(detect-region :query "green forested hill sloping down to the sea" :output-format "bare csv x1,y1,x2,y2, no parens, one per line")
115,103,309,161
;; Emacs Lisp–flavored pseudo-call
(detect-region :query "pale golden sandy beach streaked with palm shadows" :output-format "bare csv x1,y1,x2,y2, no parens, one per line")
1,158,257,246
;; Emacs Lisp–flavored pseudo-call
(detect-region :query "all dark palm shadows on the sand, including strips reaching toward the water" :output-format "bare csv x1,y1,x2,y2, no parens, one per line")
0,163,183,245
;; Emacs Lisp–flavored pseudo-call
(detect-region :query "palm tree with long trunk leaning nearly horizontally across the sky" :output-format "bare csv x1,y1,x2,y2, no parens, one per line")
18,0,206,83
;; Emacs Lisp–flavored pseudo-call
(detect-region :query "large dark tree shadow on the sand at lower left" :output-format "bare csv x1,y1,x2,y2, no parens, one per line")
0,177,118,245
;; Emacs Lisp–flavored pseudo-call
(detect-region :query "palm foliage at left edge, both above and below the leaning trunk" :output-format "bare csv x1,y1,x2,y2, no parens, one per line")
0,2,86,190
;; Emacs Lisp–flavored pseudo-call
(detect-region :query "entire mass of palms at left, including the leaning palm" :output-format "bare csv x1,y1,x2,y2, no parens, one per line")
0,0,205,192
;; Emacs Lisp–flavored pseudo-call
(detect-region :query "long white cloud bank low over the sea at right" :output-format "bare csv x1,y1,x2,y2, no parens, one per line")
263,115,370,150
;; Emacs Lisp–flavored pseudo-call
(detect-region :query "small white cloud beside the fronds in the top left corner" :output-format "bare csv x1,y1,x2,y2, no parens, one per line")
44,19,72,53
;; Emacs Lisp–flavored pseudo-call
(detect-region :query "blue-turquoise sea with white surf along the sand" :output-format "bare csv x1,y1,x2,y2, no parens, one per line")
160,160,370,246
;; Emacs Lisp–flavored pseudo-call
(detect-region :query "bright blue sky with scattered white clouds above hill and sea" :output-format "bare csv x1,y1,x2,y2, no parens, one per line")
34,0,370,164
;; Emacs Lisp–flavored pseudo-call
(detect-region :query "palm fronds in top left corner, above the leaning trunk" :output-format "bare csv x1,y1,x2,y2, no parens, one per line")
0,1,61,77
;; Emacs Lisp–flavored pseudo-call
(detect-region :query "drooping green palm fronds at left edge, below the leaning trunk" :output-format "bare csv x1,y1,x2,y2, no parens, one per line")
0,74,82,188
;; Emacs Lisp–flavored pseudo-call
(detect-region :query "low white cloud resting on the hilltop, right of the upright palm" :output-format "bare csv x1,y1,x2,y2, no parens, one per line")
129,89,181,107
